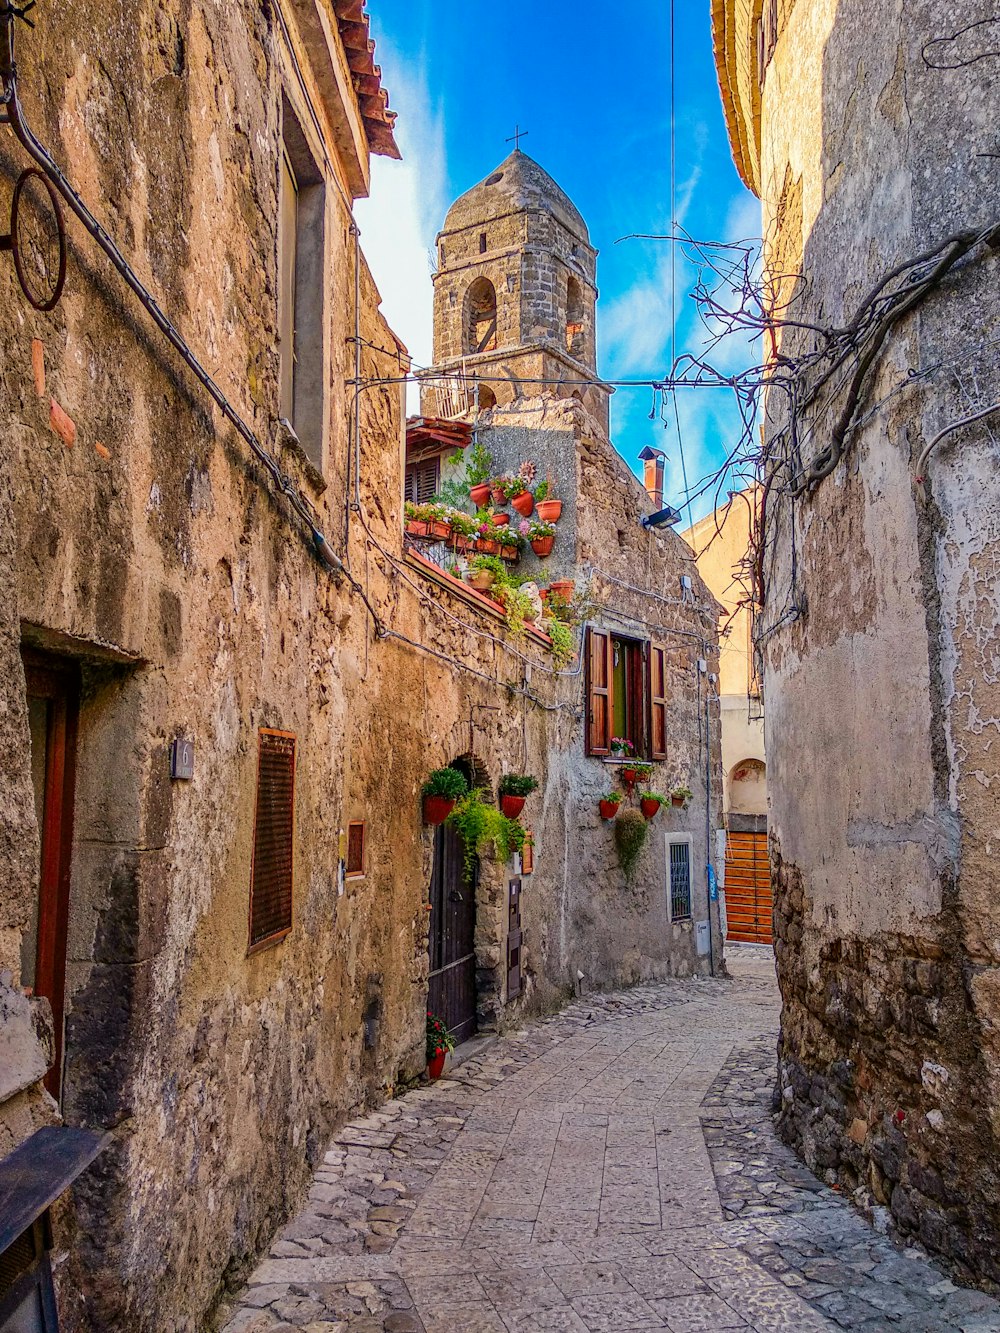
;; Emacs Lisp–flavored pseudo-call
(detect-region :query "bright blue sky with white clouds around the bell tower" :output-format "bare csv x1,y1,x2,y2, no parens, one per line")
357,0,760,519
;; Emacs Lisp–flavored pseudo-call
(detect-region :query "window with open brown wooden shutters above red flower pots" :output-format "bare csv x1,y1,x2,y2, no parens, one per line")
587,628,667,760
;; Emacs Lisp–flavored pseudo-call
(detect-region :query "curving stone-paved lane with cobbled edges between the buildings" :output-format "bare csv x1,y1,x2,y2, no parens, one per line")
218,949,1000,1333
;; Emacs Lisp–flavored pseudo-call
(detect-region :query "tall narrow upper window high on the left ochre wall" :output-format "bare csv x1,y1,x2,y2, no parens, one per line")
277,101,327,468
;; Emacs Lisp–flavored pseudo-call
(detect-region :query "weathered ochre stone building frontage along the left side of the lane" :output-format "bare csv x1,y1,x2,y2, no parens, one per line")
0,0,719,1333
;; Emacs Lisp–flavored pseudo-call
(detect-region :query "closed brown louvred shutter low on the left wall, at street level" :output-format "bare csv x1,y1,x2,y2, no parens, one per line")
249,729,295,949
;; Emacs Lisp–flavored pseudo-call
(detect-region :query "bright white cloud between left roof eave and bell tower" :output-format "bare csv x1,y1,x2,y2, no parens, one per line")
355,39,449,412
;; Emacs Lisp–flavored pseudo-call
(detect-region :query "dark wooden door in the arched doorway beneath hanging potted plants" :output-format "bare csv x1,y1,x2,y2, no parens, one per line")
427,824,479,1042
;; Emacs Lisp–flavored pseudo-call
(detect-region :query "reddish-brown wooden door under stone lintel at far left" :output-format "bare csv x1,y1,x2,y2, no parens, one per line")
21,651,80,1098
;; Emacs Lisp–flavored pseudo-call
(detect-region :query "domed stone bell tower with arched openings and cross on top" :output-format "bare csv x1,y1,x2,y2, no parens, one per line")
421,149,609,425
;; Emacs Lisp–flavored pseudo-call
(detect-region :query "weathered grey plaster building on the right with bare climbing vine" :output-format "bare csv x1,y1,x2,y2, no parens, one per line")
713,0,1000,1281
